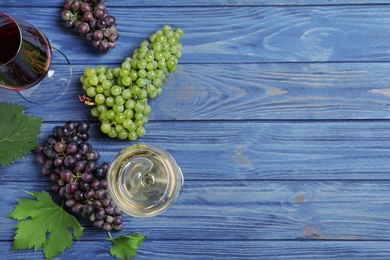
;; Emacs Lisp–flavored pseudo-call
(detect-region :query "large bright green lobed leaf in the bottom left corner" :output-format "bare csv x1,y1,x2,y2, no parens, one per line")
7,190,83,259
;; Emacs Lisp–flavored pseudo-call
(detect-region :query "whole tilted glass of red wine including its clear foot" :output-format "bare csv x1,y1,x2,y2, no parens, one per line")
0,12,72,104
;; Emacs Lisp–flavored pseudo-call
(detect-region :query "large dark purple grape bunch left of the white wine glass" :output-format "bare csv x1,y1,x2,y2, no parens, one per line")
35,121,122,231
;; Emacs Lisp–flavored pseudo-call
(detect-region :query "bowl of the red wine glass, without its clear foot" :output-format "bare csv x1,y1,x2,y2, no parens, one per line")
0,12,52,90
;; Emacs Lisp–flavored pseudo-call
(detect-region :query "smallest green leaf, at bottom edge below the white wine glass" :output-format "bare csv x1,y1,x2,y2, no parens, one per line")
107,233,146,259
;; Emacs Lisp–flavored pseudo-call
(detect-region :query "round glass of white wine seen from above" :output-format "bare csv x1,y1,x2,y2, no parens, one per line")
107,144,184,217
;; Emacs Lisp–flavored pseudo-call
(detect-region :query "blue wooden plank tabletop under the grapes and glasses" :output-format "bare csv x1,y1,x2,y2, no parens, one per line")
0,0,390,259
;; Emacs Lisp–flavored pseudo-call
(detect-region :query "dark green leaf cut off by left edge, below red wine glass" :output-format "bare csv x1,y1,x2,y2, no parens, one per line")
0,101,43,166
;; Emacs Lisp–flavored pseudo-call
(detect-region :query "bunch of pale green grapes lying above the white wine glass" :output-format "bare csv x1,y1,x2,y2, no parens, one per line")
79,25,184,140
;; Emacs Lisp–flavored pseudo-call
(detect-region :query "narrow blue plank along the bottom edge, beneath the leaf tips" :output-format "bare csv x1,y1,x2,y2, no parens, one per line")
0,241,390,260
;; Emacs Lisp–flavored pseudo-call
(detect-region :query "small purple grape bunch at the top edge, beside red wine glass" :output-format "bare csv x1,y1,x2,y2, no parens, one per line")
61,0,119,53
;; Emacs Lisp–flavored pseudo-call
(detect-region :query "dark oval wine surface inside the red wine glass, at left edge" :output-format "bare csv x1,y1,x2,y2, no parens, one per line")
0,23,20,65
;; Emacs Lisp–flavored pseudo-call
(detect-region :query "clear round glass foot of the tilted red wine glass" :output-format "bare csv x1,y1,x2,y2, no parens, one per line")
18,48,72,104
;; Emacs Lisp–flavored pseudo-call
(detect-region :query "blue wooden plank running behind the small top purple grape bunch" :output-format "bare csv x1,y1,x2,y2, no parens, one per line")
3,5,390,63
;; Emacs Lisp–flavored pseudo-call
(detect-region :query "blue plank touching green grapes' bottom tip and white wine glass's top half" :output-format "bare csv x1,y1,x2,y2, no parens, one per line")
0,121,390,181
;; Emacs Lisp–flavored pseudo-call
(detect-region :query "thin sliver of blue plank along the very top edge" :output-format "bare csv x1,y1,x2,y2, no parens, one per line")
0,0,384,7
